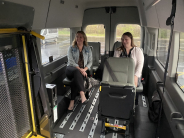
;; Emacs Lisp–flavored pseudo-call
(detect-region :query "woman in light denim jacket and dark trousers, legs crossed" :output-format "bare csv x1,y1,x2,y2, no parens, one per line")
66,31,92,112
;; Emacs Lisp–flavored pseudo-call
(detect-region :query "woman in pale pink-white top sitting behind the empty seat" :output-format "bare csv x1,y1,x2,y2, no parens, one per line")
114,32,144,87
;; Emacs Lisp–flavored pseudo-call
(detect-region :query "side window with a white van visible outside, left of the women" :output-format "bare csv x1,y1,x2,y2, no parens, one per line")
40,28,70,64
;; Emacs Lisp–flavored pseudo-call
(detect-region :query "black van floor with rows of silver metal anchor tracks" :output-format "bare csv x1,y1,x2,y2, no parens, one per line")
53,87,155,138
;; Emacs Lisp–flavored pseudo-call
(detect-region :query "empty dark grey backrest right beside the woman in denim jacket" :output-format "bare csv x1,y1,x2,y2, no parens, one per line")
88,42,101,66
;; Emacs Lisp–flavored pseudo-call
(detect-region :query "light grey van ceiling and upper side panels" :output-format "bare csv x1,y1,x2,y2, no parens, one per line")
4,0,184,32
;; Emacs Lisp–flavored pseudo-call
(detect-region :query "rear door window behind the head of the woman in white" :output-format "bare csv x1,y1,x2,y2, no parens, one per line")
115,24,141,47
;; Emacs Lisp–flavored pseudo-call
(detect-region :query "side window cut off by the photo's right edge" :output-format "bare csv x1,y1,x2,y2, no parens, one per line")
177,33,184,91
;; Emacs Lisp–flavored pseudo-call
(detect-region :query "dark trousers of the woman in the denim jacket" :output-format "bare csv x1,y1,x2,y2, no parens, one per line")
66,66,85,100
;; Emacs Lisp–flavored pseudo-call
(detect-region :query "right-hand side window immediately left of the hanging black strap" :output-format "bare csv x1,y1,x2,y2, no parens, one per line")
156,29,171,68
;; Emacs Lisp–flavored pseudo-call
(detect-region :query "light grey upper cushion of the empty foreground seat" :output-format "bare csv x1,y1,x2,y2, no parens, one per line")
102,57,135,85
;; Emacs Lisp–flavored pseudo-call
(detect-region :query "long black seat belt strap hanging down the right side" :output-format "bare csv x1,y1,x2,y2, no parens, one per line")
155,0,176,138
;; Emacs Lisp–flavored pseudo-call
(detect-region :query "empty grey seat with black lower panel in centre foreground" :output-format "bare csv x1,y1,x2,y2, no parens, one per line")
99,57,136,120
